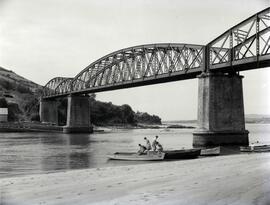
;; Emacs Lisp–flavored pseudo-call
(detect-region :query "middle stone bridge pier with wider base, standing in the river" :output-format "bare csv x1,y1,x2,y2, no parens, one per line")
63,95,93,133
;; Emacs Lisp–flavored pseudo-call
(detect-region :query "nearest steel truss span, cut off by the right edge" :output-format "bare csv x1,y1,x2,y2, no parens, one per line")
207,8,270,71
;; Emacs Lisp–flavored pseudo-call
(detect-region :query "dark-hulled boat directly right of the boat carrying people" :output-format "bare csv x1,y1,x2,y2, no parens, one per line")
163,149,201,159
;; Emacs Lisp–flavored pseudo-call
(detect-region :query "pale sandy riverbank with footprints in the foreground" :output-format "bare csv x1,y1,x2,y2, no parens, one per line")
0,153,270,205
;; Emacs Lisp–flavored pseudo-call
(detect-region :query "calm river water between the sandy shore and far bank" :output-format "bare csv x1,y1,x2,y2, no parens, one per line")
0,124,270,178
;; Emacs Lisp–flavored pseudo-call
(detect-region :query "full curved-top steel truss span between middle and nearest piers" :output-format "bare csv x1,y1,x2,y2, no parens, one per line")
71,44,203,92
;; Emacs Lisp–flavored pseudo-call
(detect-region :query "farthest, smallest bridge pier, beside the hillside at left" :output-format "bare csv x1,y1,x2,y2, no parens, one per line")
39,98,58,125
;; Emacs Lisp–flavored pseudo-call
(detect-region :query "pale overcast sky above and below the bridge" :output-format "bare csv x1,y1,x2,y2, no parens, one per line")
0,0,270,120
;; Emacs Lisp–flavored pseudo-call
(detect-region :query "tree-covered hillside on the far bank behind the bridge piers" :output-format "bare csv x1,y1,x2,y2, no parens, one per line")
0,67,161,125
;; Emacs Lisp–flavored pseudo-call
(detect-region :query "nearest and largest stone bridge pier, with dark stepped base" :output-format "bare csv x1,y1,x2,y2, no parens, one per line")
193,73,249,146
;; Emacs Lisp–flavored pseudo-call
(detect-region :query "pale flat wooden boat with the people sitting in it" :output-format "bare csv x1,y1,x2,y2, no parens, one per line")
108,151,165,161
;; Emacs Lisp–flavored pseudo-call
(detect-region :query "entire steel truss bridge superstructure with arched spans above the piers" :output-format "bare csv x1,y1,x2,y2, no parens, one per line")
42,7,270,98
